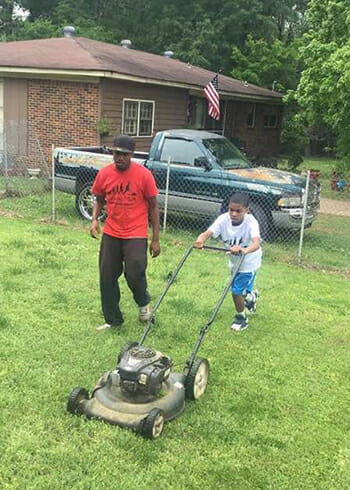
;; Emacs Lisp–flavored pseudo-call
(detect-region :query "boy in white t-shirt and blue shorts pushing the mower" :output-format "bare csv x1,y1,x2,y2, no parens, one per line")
194,193,262,332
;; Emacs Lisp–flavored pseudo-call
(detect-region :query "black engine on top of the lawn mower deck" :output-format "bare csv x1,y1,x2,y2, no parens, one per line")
117,345,173,397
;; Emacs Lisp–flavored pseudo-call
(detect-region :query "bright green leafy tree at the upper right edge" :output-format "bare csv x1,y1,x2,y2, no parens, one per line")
297,0,350,157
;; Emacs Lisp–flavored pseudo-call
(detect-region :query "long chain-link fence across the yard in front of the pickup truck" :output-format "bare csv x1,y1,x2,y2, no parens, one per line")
0,121,350,273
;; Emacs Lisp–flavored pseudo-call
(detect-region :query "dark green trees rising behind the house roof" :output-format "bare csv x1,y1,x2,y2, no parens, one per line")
8,0,305,76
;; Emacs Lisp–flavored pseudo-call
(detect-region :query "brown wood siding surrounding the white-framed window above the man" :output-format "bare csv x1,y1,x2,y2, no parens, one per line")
100,79,188,151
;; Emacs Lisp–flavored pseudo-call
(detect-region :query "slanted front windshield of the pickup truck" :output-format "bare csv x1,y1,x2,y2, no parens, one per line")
202,138,252,169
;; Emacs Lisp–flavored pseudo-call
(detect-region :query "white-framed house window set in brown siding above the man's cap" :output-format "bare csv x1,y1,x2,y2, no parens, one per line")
123,99,154,136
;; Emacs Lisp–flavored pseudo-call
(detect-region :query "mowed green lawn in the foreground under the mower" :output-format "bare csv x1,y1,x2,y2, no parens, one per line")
0,216,350,490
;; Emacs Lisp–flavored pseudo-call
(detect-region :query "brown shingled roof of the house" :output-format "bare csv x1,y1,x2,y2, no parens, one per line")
0,37,282,102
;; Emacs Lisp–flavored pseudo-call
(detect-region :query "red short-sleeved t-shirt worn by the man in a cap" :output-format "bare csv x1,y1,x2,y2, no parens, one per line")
92,161,158,238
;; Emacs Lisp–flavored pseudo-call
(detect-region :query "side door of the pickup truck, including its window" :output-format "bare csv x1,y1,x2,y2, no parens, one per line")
151,137,222,217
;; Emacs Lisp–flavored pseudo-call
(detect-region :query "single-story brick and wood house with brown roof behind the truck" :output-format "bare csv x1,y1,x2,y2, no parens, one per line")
0,35,282,163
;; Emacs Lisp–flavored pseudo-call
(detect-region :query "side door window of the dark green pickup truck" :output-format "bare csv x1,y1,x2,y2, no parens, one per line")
160,138,203,167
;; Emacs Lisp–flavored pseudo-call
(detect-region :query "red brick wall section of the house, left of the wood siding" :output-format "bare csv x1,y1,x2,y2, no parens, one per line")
28,80,99,163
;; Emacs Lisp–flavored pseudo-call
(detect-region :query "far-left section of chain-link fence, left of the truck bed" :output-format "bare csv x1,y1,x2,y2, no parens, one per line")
0,121,51,206
